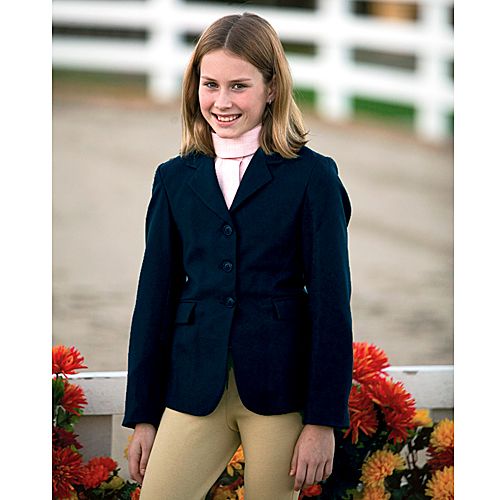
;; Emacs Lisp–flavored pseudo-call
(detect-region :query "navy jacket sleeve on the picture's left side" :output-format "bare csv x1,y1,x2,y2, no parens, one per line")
122,165,182,428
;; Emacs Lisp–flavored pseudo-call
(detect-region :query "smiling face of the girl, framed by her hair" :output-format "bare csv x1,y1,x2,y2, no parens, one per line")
198,49,274,138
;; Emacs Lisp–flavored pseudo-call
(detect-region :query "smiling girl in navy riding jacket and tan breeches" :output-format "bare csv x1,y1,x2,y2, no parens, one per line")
123,13,352,500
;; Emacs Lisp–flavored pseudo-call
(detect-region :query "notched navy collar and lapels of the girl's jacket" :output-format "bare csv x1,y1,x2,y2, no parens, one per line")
186,148,283,220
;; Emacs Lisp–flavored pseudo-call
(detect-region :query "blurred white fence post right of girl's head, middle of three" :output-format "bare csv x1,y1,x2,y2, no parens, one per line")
316,0,351,120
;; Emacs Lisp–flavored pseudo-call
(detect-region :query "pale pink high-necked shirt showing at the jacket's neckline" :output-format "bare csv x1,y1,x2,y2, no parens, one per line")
212,127,262,208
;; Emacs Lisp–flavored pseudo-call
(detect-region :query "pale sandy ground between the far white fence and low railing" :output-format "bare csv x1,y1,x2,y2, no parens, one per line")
53,91,453,370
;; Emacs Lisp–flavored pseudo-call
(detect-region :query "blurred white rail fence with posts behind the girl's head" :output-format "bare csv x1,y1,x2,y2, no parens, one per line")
52,0,453,140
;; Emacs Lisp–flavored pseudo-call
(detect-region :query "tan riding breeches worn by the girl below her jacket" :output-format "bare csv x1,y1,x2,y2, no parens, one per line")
141,368,303,500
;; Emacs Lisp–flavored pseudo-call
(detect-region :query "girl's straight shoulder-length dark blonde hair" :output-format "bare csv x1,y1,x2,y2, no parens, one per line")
181,12,307,158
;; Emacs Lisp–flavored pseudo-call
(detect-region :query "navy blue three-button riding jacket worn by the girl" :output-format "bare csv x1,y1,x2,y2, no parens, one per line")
123,146,352,428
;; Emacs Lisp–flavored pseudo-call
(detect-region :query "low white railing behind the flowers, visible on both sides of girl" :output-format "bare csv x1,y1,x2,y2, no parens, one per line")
70,365,454,476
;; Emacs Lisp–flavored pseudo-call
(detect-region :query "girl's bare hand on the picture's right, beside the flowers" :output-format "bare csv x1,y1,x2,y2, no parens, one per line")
290,424,335,491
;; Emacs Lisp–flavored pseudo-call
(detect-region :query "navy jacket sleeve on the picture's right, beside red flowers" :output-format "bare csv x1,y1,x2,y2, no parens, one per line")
302,157,353,427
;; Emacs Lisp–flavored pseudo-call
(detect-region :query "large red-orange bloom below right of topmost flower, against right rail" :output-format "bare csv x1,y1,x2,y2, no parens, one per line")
368,378,415,443
